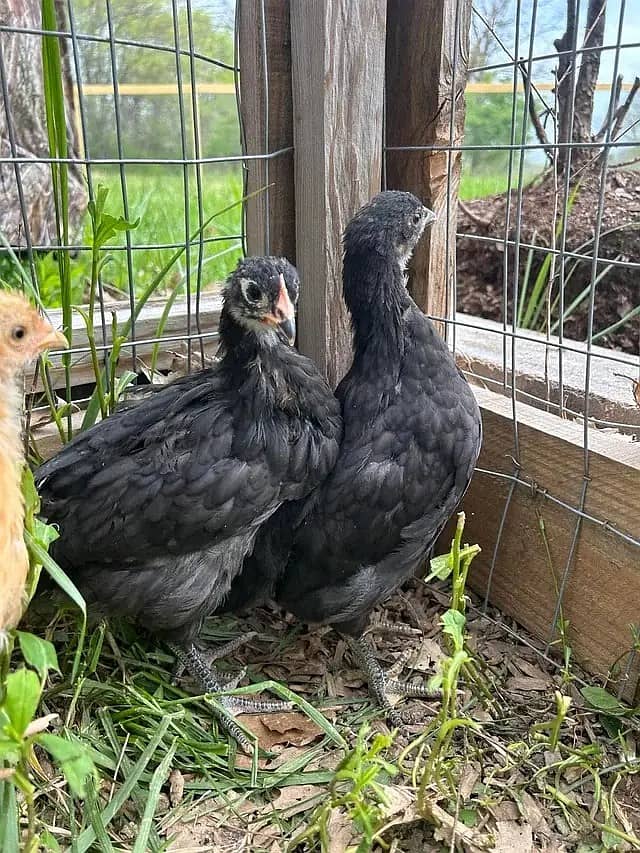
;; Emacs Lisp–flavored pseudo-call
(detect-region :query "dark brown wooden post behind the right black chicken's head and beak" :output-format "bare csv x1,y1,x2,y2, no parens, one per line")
386,0,471,326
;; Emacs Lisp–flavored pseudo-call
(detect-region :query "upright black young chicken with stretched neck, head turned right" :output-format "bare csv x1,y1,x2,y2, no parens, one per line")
242,192,482,724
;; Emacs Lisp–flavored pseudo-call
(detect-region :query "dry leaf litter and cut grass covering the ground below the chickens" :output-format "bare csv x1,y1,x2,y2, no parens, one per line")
20,568,640,853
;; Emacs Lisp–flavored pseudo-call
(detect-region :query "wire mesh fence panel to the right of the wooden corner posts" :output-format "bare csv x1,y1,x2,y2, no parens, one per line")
390,0,640,694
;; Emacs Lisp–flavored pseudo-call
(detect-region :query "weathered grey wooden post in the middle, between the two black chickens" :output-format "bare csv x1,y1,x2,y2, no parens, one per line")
291,0,386,385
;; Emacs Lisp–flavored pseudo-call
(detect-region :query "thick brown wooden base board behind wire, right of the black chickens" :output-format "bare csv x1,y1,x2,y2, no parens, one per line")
450,388,640,701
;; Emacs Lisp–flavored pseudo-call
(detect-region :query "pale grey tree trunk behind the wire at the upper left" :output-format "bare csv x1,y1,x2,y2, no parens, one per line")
0,0,86,249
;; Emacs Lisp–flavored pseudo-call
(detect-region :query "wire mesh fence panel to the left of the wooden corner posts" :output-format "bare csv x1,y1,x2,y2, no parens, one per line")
0,0,264,380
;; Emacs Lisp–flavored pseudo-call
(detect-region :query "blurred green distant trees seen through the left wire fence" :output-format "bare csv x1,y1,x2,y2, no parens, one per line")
74,0,239,159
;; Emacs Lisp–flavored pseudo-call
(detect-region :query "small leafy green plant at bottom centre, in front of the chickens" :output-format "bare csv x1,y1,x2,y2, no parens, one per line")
287,723,398,853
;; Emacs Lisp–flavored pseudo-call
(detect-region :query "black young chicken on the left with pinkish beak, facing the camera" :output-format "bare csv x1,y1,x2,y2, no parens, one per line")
36,257,342,739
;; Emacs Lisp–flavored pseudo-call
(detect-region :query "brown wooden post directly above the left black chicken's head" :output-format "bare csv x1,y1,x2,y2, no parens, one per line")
239,0,296,263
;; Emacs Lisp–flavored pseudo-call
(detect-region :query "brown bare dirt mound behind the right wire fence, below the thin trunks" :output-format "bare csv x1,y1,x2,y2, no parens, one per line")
457,169,640,354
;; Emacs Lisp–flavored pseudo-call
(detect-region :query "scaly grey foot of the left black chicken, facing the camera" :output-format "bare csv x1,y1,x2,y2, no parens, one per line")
168,638,293,753
